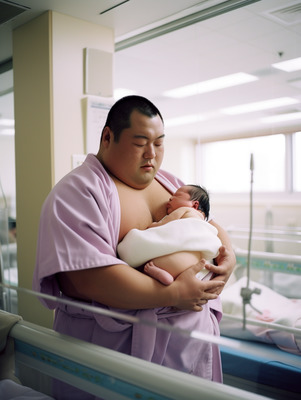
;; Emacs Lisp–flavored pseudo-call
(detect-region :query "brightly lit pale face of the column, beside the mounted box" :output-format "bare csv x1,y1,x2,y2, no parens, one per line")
52,12,114,183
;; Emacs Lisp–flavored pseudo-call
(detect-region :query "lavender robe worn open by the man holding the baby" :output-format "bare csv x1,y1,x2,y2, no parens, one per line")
33,154,222,396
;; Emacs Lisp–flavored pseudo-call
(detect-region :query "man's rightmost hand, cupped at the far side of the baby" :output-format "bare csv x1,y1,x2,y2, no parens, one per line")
205,246,236,294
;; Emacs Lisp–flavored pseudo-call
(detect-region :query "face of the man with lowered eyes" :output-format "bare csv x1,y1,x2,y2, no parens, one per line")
102,110,164,189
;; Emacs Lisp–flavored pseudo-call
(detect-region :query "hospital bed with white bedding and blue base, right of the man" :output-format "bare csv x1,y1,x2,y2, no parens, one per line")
220,227,301,399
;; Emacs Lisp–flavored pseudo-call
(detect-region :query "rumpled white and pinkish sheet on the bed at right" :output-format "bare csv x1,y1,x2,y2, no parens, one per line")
220,277,301,355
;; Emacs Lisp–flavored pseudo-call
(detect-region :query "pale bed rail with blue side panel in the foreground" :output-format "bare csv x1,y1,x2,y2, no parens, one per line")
0,304,272,400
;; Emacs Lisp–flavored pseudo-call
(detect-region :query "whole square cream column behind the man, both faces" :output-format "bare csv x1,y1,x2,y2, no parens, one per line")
13,11,114,327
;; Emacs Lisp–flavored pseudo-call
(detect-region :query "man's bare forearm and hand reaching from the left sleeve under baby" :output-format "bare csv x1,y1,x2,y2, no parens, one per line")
58,263,224,311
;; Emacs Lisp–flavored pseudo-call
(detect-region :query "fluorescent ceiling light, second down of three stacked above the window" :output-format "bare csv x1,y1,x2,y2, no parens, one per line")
221,97,299,115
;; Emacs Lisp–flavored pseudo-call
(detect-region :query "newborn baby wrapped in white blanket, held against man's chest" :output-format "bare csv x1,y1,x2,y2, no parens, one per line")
118,185,221,285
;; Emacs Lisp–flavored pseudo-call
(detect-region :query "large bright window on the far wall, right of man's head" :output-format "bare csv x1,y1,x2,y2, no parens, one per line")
198,134,286,193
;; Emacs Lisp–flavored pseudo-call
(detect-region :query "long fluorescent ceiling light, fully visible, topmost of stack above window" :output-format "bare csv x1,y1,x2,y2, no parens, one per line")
163,72,258,99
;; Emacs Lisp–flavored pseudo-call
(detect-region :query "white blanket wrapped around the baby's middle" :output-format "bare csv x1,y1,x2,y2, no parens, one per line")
117,218,221,268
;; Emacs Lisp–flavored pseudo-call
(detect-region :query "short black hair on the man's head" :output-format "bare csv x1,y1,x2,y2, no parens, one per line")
105,96,164,142
